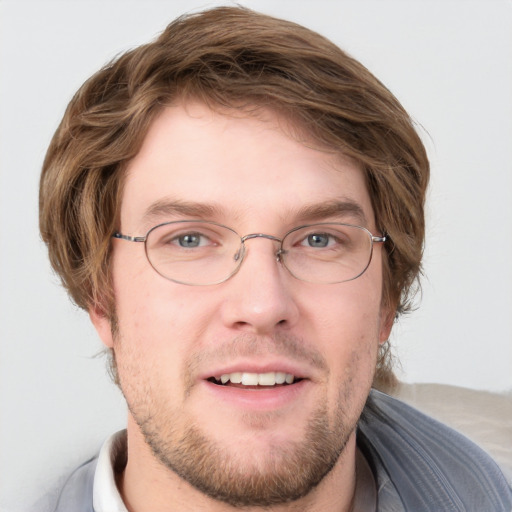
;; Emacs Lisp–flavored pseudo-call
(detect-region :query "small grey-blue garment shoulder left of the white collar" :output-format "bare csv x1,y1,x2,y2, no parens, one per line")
29,458,97,512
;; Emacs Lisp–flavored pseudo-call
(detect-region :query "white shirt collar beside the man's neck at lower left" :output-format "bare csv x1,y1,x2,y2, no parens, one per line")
92,430,128,512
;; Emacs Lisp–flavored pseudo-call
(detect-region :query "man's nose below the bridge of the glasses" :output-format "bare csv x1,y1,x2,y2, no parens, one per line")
220,235,299,335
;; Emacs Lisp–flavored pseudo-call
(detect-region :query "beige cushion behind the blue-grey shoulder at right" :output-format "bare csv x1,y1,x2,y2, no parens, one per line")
392,383,512,485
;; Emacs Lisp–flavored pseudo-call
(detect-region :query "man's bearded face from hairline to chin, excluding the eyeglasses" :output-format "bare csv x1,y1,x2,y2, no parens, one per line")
91,104,391,506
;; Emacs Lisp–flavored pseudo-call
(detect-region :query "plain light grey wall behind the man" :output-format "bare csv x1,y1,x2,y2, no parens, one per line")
0,0,512,510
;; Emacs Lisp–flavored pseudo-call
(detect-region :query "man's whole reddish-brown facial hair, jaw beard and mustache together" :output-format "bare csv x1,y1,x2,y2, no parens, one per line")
114,336,366,507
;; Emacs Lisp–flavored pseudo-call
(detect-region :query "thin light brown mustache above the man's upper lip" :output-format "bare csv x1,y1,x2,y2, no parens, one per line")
185,333,329,381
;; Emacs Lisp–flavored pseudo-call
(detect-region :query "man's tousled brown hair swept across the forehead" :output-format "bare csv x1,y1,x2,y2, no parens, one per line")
40,7,429,388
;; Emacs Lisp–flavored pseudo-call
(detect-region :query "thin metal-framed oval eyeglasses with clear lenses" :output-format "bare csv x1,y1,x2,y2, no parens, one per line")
113,220,386,286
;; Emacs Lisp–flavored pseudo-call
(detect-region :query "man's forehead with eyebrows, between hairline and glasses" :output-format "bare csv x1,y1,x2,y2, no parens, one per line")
121,103,373,232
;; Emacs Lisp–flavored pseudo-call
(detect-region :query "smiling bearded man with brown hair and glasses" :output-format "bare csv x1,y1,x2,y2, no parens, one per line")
40,8,512,512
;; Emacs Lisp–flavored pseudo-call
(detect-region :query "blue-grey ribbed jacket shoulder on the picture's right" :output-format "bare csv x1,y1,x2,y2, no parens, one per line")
358,391,512,512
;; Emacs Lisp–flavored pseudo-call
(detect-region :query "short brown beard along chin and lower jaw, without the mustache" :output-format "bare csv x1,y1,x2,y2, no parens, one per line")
136,396,350,507
